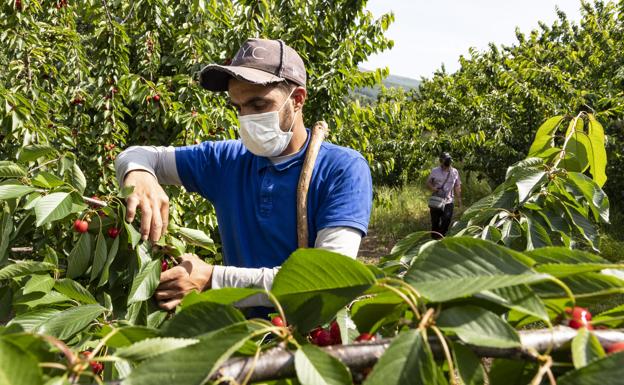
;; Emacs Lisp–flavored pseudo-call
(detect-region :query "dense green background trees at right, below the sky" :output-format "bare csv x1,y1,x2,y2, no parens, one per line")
337,1,624,207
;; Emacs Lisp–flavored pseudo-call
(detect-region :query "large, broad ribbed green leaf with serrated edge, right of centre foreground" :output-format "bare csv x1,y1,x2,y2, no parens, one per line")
405,237,547,302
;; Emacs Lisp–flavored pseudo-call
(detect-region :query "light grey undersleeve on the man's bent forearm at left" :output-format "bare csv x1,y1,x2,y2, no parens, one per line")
115,146,182,186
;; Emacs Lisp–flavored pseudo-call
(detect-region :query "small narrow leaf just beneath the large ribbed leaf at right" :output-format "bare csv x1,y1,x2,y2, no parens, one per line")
475,285,550,323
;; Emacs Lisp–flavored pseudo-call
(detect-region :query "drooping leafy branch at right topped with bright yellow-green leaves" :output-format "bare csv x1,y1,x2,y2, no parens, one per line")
451,113,609,251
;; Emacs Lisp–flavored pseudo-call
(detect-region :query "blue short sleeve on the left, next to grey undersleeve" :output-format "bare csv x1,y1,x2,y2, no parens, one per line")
175,141,243,201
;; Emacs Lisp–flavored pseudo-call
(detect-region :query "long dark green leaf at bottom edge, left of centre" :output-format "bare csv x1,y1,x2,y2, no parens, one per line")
124,324,250,385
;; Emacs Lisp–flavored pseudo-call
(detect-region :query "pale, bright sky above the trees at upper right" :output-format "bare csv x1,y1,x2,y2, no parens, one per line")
361,0,581,79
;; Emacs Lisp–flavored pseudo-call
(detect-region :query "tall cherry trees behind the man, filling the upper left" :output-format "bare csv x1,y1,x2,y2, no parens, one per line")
0,0,393,246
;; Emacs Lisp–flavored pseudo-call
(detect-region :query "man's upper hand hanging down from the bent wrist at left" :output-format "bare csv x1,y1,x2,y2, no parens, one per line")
124,170,169,242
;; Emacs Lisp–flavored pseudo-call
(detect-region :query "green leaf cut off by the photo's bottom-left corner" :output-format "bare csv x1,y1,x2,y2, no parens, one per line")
0,339,43,385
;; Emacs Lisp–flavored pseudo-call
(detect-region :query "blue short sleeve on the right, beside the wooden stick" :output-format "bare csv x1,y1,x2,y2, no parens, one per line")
315,157,373,235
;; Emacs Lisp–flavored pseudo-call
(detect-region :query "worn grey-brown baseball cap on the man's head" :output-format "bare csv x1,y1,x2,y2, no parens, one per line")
199,39,306,91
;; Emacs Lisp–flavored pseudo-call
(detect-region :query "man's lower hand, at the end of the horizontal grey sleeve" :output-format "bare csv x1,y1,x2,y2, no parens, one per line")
154,254,212,311
